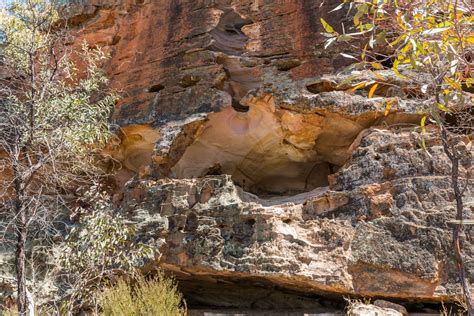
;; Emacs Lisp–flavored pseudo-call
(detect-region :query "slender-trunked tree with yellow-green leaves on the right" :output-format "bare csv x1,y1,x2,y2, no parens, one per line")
321,0,474,314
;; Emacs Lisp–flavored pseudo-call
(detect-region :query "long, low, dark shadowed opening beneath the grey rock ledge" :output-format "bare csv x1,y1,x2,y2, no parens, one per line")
160,270,456,316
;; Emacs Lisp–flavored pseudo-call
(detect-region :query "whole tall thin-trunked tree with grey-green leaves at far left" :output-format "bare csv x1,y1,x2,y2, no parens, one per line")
0,0,117,314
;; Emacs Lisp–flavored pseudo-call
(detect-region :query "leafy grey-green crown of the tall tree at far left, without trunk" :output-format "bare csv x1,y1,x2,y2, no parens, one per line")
0,0,117,162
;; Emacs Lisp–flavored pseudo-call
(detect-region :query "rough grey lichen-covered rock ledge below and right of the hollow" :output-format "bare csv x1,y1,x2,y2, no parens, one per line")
119,128,474,306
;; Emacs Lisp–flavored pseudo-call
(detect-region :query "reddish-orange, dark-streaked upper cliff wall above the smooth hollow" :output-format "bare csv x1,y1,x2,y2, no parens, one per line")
72,0,363,188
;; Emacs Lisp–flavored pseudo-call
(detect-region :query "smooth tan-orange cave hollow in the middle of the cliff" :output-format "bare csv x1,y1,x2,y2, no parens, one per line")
171,104,358,197
